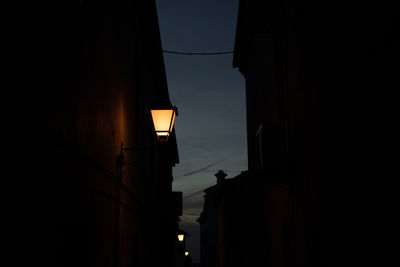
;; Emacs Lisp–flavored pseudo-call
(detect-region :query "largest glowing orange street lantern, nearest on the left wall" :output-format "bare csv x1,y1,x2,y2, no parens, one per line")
151,107,178,142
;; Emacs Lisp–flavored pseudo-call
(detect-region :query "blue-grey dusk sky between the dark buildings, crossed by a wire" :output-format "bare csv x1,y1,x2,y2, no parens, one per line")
156,0,247,262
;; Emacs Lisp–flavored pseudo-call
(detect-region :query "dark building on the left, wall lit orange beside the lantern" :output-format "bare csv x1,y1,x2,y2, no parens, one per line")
5,0,182,267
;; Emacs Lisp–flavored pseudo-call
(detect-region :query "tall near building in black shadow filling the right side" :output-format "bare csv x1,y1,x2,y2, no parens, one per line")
233,0,398,266
